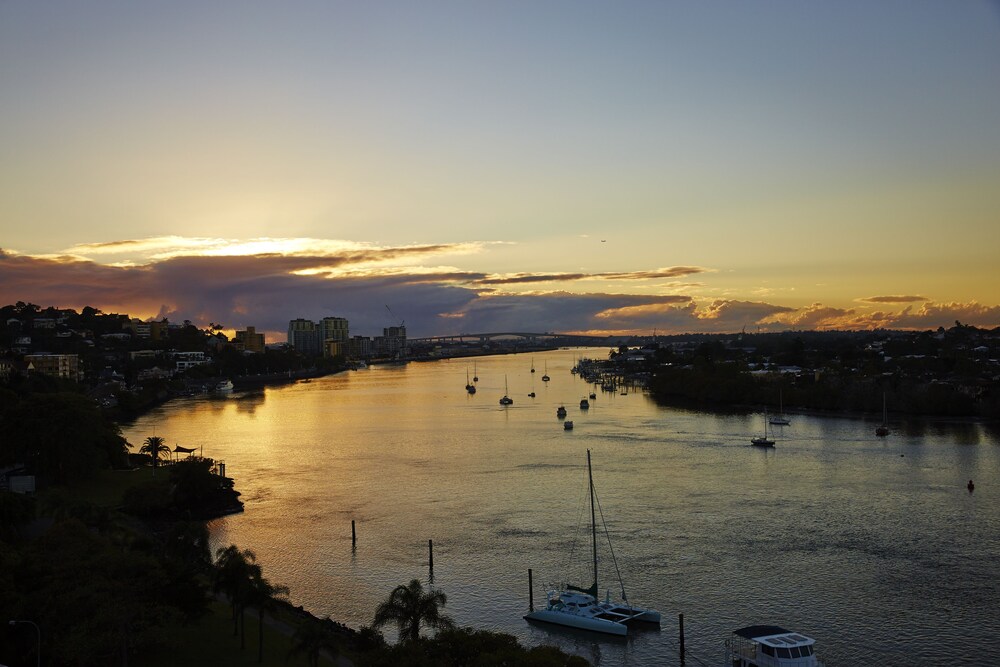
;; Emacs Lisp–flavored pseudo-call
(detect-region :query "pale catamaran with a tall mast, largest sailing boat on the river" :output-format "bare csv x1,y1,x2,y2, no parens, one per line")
524,449,660,636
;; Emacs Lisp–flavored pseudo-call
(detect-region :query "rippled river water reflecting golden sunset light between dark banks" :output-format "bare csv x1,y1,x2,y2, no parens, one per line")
126,349,1000,666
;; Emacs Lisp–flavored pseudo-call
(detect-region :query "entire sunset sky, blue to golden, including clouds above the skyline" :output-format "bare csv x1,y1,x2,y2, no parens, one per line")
0,0,1000,341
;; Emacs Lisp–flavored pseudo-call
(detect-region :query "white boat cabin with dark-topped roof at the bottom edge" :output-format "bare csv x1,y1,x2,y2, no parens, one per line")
726,625,823,667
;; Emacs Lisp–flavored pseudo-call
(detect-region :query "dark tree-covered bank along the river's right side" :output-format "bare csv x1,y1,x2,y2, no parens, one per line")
646,325,1000,419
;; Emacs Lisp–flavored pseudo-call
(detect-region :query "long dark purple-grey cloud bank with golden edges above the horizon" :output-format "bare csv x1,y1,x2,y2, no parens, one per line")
0,250,1000,337
